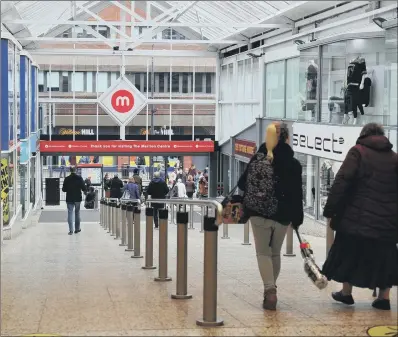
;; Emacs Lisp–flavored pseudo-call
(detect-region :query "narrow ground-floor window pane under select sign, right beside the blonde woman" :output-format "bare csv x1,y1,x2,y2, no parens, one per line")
296,153,317,217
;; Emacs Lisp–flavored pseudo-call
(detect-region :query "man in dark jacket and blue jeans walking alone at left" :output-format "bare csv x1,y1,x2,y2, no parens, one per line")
62,166,86,235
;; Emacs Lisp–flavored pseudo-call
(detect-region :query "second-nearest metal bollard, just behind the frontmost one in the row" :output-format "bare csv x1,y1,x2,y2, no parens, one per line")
171,207,192,300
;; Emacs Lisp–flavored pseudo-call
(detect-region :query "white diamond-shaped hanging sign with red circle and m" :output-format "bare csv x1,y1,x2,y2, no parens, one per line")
98,77,147,125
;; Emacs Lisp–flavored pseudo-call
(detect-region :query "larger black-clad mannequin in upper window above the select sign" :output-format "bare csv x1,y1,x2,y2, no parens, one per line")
343,56,369,124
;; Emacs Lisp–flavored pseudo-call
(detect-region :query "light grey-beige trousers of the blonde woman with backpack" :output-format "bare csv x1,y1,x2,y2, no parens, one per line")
250,216,288,290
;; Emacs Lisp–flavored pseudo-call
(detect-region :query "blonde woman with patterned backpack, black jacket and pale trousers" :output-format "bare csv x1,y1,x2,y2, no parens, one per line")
238,122,304,310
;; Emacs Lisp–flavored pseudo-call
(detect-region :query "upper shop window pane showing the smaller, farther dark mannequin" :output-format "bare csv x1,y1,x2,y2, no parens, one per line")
297,47,319,121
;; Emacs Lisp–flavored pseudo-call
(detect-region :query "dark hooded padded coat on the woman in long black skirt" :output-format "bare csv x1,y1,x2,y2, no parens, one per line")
323,136,398,242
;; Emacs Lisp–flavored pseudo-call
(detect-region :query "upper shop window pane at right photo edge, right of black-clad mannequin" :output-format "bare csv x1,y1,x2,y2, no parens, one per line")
384,27,398,126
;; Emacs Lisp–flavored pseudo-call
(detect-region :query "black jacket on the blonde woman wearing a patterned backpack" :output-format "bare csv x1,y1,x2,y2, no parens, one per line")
238,143,304,227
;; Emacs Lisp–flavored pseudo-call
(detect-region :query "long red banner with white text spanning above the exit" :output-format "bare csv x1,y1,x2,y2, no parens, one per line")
40,140,214,153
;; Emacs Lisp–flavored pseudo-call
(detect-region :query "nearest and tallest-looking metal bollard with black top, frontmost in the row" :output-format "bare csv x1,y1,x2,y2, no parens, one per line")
196,215,224,327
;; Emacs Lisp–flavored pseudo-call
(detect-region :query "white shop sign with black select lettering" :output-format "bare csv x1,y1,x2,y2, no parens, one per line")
292,123,362,161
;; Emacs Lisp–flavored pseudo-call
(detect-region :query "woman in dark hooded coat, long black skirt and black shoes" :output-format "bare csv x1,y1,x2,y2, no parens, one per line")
322,123,398,310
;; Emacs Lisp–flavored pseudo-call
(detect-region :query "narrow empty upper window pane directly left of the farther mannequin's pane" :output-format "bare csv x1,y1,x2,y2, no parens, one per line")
286,57,301,119
